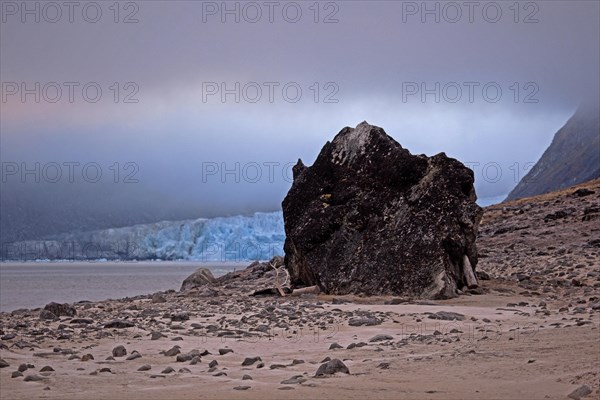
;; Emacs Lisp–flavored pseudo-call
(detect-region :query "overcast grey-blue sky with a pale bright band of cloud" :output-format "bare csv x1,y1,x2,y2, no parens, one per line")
0,1,600,225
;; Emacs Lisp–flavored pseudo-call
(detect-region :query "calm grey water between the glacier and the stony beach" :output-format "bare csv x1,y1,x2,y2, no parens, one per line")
0,262,244,311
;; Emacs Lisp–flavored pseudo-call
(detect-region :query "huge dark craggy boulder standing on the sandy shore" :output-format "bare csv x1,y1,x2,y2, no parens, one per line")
283,122,482,298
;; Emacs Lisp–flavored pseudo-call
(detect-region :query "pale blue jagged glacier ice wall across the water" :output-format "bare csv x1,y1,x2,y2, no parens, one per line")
0,211,285,262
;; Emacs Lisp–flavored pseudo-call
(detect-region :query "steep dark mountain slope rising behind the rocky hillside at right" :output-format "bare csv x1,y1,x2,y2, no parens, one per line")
504,105,600,201
